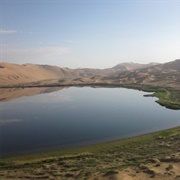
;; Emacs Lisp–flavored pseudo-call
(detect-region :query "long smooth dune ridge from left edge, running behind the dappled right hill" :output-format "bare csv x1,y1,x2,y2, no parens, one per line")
0,63,156,86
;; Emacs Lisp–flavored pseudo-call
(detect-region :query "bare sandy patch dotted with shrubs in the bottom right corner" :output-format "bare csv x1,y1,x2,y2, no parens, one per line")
90,162,180,180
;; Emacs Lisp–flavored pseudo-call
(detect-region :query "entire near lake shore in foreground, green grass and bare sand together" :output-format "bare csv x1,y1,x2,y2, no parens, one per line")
0,127,180,180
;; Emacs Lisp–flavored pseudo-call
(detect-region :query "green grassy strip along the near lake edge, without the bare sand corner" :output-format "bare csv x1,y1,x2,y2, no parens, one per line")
0,127,180,179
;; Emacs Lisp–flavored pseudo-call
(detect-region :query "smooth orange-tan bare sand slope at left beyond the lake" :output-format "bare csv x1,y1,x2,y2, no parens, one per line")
0,63,79,85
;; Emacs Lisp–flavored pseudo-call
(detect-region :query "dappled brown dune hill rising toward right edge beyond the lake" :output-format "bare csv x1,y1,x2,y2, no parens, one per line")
101,59,180,89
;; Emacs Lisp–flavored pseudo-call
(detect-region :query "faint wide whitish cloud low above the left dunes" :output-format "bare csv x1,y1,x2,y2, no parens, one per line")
1,47,69,63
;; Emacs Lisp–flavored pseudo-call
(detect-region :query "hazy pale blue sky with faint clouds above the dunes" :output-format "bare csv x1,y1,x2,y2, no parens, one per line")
0,0,180,68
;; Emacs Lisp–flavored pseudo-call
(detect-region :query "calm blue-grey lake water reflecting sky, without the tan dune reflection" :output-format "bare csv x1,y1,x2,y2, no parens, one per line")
0,87,180,156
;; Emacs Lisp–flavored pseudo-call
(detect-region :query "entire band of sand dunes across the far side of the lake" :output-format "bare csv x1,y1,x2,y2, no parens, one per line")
0,59,180,89
